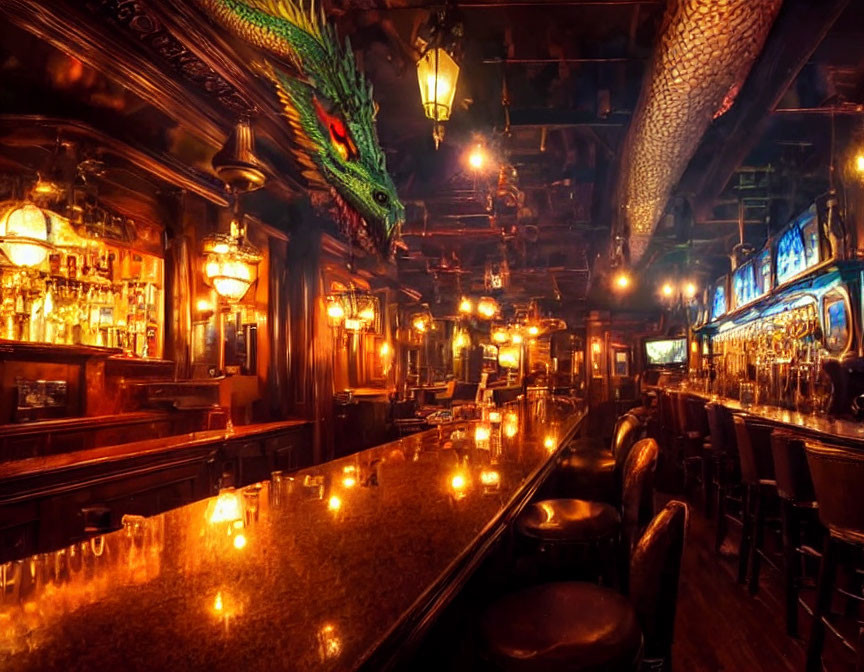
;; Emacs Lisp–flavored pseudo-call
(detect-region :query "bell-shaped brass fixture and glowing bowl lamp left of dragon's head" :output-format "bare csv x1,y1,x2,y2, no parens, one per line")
201,119,267,303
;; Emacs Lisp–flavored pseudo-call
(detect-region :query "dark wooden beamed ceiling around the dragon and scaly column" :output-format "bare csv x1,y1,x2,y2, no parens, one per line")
0,0,864,320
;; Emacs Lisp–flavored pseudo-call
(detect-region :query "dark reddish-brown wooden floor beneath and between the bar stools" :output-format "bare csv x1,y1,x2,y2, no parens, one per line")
412,488,854,672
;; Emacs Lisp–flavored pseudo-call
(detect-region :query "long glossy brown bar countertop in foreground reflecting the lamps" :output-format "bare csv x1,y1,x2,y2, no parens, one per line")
0,405,584,672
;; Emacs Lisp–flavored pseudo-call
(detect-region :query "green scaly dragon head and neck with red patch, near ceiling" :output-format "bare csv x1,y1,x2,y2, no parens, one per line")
197,0,405,258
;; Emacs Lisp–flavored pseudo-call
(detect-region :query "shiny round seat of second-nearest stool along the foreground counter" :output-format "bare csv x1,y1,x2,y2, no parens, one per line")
516,499,621,543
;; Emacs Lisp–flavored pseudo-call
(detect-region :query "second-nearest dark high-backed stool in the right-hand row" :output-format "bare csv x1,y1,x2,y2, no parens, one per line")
771,429,822,637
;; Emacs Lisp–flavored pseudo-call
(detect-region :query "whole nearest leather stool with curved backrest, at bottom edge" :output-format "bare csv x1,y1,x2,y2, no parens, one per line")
479,501,688,672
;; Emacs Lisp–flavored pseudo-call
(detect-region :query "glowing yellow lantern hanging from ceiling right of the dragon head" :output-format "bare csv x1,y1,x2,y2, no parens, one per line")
417,7,462,149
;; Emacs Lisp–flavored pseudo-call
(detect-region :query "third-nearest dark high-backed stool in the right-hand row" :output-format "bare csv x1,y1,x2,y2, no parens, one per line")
733,415,777,595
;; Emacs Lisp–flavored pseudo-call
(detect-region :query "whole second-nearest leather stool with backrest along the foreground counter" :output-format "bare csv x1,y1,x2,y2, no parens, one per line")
515,439,658,584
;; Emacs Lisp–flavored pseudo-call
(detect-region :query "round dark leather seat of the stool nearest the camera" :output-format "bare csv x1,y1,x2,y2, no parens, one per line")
480,581,642,672
